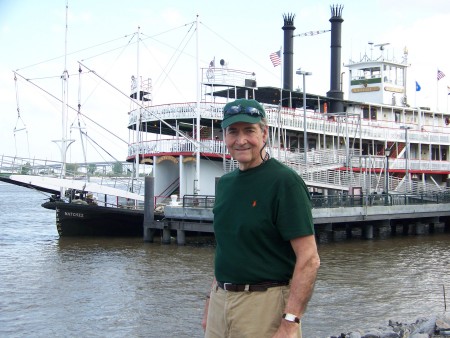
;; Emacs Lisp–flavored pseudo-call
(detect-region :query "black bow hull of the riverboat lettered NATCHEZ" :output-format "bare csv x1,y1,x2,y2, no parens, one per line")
42,201,144,237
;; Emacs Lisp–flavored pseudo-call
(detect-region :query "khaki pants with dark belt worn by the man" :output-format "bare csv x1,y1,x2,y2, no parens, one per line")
205,286,302,338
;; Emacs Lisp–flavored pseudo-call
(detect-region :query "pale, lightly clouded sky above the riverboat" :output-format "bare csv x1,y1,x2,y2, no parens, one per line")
0,0,450,162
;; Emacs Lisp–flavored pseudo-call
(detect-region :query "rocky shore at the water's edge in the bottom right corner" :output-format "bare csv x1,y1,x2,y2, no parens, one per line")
328,313,450,338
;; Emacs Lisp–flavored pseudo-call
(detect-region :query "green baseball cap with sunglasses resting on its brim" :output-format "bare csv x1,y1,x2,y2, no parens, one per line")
221,99,266,129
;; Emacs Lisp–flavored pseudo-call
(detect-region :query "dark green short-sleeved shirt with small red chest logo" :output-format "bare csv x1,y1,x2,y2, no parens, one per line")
213,159,314,284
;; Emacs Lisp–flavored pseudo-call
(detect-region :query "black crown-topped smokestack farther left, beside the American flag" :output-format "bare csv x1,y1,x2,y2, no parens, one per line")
283,14,295,91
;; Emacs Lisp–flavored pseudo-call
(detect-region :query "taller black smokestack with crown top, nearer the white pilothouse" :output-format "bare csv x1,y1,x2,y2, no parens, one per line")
327,5,344,113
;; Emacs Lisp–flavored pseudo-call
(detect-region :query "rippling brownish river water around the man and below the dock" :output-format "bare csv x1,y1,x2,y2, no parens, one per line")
0,183,450,338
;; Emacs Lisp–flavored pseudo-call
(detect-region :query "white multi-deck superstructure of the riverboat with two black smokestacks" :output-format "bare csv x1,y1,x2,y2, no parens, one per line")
127,7,450,203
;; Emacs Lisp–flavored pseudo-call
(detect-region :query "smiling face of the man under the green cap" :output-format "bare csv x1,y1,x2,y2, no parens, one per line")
225,122,268,170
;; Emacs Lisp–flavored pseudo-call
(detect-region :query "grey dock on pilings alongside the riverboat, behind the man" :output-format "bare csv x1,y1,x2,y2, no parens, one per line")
144,177,450,245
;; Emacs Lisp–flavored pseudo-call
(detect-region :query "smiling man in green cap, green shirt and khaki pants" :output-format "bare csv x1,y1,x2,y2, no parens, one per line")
202,99,320,338
